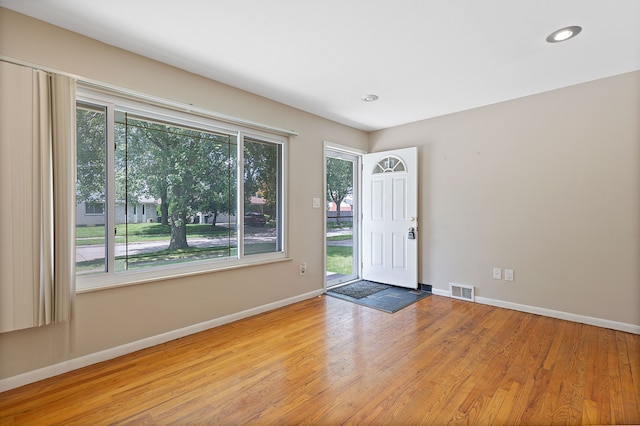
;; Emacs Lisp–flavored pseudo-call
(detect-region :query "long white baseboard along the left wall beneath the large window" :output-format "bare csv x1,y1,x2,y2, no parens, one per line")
0,289,324,392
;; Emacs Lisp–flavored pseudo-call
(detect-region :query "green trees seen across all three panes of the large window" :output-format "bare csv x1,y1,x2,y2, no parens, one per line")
77,107,281,253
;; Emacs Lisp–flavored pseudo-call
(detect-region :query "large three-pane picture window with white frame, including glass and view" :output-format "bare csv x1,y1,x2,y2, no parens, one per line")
76,90,285,289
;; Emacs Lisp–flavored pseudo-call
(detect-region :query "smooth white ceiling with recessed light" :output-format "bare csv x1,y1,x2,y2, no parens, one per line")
0,0,640,130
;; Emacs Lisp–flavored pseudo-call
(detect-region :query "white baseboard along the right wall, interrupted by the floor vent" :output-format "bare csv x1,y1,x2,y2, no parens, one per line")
431,288,640,334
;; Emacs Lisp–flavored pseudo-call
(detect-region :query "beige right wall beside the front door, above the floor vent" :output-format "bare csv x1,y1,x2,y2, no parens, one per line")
370,72,640,325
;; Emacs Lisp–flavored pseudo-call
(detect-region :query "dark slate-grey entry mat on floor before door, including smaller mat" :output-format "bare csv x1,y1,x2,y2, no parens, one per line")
327,280,431,314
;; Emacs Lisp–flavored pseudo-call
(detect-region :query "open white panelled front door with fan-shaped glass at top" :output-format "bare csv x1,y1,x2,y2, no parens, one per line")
362,147,418,288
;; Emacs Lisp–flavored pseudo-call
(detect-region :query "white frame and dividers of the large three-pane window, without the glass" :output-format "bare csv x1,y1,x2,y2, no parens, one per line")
74,84,289,293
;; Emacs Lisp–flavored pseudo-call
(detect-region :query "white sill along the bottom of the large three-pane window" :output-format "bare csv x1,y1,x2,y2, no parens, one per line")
76,255,292,294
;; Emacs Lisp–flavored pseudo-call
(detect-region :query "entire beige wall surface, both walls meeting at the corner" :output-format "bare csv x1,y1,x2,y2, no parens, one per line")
0,8,640,379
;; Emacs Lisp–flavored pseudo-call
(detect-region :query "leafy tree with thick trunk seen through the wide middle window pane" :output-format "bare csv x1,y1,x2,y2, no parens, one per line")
117,117,231,249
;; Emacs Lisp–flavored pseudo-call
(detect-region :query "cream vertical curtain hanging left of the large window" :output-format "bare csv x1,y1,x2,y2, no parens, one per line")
0,62,76,332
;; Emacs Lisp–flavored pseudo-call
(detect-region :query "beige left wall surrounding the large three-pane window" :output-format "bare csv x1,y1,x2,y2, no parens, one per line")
0,8,368,378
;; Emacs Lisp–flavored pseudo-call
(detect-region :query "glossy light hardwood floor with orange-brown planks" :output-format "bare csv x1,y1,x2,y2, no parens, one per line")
0,296,640,425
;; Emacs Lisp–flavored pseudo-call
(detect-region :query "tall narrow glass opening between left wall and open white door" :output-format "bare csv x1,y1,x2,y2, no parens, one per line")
325,148,360,288
